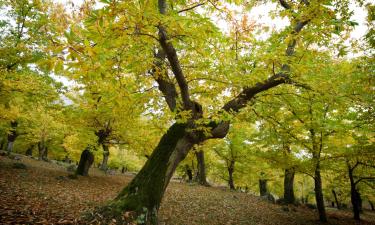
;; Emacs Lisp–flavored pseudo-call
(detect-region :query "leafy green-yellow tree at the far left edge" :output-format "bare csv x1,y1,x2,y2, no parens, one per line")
0,0,61,153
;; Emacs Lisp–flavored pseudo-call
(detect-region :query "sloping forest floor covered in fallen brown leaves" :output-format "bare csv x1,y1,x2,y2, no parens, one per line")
0,156,375,225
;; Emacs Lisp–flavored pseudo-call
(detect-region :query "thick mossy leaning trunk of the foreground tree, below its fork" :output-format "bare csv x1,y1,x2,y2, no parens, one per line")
94,123,195,224
